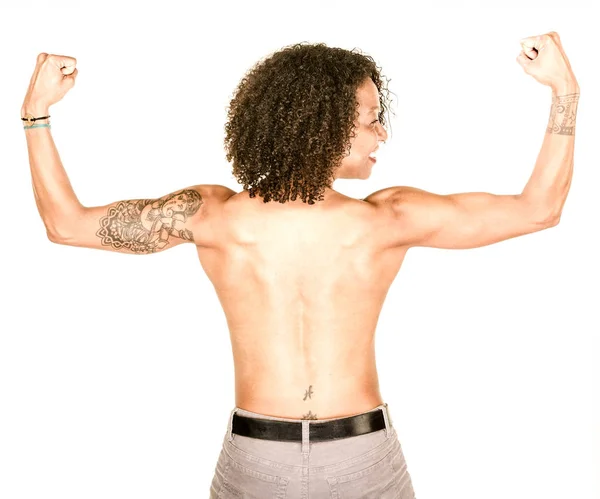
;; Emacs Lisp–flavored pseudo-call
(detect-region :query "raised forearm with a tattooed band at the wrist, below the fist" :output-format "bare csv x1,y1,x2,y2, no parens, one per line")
521,81,579,221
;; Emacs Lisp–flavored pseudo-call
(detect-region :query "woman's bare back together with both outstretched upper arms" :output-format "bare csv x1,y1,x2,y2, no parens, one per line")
59,178,560,419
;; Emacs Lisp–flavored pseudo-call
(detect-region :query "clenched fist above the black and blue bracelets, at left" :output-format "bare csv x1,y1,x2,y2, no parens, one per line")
21,53,78,114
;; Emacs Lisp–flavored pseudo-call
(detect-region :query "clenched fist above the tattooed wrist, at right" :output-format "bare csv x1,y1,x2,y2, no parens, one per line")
517,31,579,90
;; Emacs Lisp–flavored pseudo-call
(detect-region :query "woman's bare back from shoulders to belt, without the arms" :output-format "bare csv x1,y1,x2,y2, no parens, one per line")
197,191,406,419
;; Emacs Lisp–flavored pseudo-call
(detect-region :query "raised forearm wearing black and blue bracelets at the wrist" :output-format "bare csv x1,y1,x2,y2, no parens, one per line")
22,101,82,237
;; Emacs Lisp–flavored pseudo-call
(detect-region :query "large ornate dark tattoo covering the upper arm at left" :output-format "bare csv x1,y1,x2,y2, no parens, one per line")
96,189,204,253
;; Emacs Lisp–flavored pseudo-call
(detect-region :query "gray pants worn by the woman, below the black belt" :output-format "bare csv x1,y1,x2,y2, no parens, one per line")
210,404,415,499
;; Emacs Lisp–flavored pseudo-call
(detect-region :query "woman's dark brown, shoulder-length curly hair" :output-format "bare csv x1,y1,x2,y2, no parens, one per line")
225,43,391,204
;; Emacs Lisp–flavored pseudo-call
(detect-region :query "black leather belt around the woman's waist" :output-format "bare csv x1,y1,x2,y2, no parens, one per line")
231,409,385,442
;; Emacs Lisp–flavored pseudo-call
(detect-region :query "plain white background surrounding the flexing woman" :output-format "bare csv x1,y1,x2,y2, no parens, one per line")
0,0,600,499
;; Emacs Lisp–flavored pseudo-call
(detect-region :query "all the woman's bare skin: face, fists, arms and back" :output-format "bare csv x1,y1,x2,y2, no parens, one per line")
22,35,579,419
